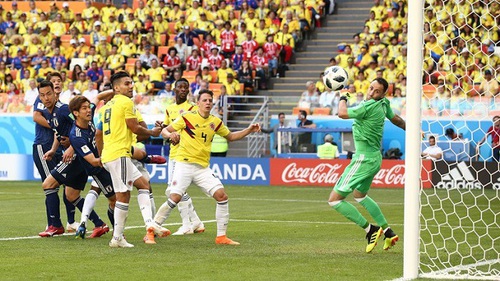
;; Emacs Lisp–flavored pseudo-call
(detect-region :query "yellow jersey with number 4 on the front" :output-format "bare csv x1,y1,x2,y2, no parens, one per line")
172,111,230,168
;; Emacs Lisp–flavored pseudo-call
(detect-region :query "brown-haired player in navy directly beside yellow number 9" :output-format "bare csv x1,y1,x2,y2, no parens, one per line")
69,96,116,238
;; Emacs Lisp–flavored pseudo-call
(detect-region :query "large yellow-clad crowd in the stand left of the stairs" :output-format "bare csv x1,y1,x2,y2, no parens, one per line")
0,0,329,113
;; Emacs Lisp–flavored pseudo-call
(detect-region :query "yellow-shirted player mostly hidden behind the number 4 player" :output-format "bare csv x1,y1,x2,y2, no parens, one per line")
159,78,205,235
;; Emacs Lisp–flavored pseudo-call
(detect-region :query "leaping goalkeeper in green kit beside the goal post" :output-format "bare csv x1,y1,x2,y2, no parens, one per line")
328,78,406,253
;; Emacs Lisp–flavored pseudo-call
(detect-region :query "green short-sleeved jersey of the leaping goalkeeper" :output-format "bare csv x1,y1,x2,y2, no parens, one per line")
347,98,394,153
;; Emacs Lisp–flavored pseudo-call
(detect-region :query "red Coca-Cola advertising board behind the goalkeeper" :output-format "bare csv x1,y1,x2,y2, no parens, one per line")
270,158,432,188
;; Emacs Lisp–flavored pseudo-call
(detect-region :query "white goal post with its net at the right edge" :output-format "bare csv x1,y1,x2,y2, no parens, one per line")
403,0,500,280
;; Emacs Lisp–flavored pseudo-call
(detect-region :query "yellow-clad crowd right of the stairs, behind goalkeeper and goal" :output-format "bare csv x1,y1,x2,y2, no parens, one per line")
297,0,500,116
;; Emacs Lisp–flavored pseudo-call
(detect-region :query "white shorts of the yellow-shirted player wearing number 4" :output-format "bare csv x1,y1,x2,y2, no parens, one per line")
166,162,224,197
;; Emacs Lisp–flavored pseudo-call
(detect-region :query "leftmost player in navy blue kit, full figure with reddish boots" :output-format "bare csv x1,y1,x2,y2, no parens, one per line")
38,80,109,237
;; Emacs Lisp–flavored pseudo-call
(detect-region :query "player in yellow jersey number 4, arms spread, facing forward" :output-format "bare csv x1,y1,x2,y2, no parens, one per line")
154,90,260,245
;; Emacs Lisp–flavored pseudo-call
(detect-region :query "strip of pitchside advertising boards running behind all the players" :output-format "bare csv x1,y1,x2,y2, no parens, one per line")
0,154,500,190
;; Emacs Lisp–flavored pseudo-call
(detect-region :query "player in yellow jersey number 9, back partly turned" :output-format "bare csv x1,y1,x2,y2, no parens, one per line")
101,71,169,248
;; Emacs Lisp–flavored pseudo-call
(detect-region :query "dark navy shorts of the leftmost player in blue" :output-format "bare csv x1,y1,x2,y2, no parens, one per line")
50,159,88,190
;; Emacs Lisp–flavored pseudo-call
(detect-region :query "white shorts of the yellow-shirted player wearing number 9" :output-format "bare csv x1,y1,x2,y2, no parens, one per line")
104,157,142,192
